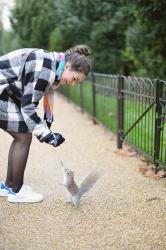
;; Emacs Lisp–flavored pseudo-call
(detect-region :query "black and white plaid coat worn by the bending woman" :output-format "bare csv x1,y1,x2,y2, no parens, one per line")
0,49,58,138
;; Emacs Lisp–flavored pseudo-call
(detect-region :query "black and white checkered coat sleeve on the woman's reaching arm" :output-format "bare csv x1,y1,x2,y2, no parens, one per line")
21,48,55,138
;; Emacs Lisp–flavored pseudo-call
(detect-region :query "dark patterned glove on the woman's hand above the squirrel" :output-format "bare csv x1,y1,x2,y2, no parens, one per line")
39,132,65,147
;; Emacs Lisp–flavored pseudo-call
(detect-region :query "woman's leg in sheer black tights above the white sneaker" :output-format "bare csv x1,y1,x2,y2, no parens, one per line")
5,131,32,192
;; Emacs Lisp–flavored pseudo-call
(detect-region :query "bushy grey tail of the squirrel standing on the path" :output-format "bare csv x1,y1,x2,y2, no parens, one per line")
79,168,104,195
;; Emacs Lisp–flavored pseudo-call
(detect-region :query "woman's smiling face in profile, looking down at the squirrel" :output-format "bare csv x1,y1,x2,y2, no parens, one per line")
60,63,86,85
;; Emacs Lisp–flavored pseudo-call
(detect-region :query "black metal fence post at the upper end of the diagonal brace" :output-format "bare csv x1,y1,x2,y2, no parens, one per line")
154,80,163,173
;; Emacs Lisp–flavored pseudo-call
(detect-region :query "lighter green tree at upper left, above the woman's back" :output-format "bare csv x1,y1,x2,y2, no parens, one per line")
11,0,56,49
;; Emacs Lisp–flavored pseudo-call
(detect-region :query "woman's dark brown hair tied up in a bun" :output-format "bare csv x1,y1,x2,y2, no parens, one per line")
65,44,92,75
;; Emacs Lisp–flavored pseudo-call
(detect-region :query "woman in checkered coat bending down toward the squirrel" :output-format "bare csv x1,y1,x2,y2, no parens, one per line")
0,45,91,202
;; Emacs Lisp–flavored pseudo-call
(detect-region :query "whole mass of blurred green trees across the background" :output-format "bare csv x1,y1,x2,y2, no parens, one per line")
11,0,166,78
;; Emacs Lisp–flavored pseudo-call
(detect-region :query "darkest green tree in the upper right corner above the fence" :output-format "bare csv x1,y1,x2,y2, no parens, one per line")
126,0,166,78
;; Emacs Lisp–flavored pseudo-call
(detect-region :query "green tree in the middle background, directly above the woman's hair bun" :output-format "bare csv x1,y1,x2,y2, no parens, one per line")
53,0,134,73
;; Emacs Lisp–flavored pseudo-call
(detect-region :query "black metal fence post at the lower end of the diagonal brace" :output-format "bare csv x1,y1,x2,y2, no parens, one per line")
117,76,124,149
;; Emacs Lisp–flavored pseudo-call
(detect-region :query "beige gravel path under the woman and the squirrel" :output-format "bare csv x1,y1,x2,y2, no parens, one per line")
0,94,166,250
